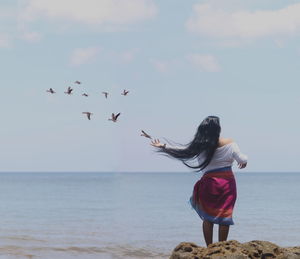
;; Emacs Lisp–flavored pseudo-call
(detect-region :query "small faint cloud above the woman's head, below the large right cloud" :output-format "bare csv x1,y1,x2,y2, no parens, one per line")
187,54,221,72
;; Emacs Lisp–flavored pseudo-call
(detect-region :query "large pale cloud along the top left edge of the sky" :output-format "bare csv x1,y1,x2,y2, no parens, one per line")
23,0,157,25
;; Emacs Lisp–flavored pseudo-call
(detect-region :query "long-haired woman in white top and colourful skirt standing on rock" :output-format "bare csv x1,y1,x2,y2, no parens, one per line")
151,116,247,246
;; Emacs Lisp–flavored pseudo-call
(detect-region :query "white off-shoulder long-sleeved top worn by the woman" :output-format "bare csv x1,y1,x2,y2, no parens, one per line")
199,142,248,173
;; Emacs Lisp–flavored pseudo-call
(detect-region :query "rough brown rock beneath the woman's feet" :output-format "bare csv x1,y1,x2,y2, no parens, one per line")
170,240,300,259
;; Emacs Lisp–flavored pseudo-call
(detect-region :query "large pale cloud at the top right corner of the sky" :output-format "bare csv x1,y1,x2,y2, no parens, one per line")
186,4,300,40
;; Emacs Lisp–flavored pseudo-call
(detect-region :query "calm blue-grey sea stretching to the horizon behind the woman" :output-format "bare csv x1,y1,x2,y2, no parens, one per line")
0,171,300,259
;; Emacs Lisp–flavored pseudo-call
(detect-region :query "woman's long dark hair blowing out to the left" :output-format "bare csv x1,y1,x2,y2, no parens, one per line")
158,116,221,171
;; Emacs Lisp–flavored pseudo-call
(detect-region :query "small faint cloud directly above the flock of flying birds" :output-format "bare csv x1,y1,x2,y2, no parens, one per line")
70,47,101,66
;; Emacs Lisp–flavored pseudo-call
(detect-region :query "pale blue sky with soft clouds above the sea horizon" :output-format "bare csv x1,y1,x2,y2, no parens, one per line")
0,0,300,172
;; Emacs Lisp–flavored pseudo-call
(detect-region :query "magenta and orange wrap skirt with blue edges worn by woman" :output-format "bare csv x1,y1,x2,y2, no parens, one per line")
190,167,236,225
